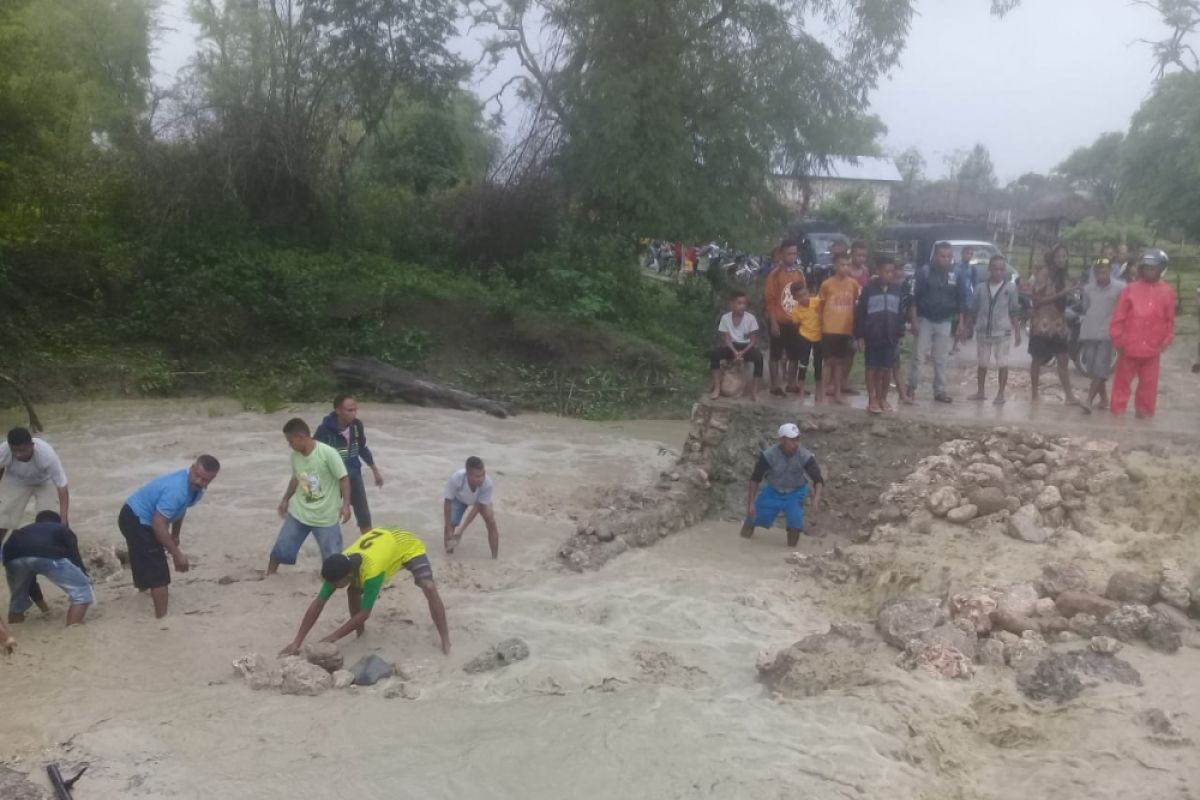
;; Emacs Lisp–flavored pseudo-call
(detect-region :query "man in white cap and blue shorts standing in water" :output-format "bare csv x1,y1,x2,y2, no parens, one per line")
742,422,824,547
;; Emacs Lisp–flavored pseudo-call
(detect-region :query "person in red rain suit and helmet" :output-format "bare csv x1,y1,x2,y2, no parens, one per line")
1109,249,1175,419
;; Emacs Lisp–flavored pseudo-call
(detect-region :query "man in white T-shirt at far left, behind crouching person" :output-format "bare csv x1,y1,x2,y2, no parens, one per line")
0,428,71,612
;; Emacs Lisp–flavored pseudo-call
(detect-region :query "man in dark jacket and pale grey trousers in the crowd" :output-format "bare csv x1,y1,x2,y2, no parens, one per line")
908,237,965,403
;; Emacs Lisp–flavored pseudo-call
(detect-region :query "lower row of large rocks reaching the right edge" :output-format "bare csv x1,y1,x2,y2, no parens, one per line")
876,563,1198,678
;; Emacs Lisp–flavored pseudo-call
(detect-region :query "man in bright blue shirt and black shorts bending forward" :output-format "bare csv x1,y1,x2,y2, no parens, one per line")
116,456,221,619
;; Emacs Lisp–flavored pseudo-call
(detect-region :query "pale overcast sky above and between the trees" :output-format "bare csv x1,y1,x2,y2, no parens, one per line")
155,0,1163,182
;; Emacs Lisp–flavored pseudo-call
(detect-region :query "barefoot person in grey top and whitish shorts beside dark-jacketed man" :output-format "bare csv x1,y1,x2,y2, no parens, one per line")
964,255,1021,405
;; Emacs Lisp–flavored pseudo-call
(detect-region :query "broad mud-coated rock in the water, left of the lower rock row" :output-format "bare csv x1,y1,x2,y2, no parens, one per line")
758,625,878,697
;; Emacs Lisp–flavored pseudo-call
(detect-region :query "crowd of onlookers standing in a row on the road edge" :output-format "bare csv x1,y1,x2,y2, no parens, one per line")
709,240,1176,417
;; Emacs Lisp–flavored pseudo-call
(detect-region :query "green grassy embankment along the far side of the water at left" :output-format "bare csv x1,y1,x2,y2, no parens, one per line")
2,246,712,419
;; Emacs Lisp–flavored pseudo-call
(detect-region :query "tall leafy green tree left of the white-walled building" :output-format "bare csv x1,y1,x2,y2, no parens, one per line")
473,0,912,236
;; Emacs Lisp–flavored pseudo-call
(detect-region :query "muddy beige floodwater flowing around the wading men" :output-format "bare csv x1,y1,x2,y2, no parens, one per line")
0,401,1200,800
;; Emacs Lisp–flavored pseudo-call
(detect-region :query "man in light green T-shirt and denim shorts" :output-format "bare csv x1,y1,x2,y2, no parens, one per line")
266,417,350,575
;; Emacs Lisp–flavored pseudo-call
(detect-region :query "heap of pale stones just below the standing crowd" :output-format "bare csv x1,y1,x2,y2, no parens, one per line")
872,428,1129,543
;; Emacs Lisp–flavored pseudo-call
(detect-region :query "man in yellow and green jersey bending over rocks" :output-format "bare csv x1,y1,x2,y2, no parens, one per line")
280,528,450,655
